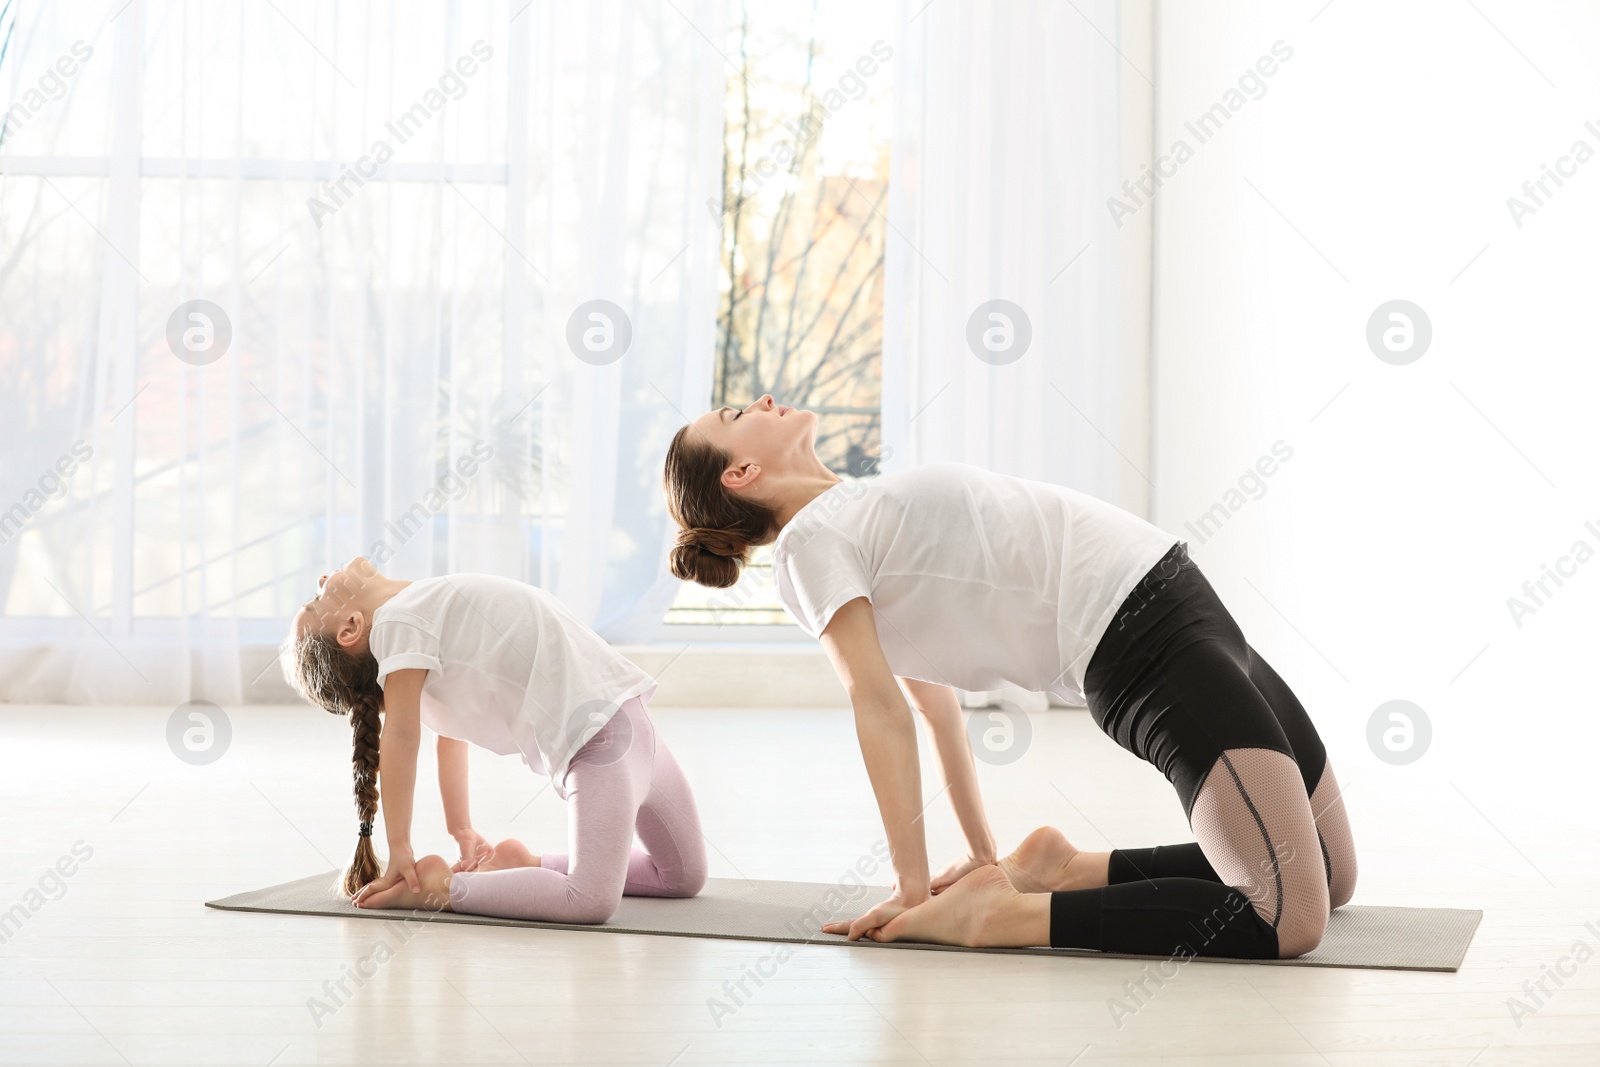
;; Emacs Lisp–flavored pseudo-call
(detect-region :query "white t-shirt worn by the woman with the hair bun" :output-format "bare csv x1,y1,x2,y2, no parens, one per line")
773,462,1178,704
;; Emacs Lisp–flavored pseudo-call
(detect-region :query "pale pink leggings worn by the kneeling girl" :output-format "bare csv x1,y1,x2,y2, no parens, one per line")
450,697,706,923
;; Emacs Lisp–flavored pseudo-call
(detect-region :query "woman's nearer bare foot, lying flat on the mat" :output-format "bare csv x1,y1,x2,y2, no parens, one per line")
872,864,1050,949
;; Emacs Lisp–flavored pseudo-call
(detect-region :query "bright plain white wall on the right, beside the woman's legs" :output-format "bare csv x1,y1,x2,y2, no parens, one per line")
1154,0,1600,831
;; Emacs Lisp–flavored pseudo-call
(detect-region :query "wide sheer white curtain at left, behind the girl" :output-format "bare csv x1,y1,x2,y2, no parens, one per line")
0,0,726,704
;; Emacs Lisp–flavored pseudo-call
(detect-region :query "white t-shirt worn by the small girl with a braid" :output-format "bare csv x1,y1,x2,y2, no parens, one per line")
368,574,656,784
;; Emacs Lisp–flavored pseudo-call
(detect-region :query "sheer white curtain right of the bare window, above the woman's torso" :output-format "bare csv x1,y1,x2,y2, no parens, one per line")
883,0,1149,514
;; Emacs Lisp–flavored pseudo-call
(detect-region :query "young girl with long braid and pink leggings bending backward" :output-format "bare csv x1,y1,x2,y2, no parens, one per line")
285,557,706,923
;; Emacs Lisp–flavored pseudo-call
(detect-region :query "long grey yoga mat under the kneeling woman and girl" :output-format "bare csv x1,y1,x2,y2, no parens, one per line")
206,870,1483,971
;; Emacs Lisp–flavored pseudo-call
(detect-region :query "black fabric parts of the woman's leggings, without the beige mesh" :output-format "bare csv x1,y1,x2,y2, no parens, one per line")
1050,542,1342,960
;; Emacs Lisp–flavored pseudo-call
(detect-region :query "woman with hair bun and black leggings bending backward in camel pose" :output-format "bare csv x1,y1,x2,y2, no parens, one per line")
666,397,1355,960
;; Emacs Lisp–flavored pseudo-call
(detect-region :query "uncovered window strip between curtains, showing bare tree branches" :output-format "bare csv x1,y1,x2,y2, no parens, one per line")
667,0,894,627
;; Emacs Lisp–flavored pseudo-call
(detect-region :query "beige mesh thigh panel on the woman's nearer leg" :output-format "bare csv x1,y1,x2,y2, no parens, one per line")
1189,749,1328,958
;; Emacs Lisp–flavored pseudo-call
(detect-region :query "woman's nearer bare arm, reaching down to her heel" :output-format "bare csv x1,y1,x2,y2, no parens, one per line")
822,597,928,941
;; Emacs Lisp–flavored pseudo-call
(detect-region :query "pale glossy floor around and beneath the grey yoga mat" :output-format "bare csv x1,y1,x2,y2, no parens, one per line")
0,705,1600,1067
